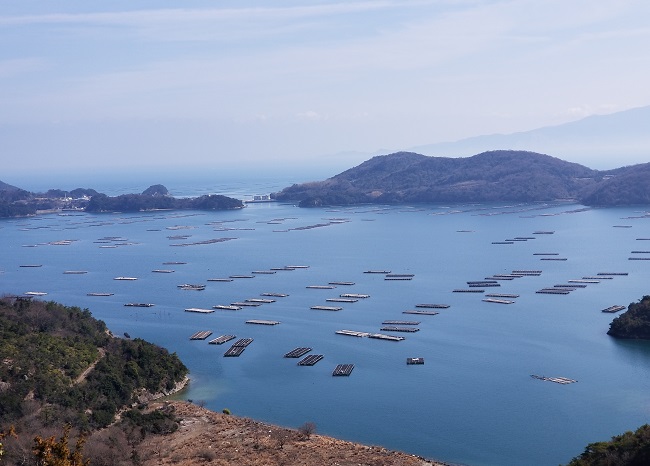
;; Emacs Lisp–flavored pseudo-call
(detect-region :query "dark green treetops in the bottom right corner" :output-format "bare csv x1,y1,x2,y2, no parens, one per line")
569,424,650,466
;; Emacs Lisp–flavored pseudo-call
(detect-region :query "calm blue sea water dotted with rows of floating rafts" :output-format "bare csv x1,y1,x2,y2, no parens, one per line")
0,173,650,466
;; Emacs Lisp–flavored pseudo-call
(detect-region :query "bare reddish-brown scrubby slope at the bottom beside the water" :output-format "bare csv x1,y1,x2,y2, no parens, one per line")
139,401,443,466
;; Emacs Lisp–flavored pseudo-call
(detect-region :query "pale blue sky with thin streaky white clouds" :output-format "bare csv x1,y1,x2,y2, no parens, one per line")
0,0,650,182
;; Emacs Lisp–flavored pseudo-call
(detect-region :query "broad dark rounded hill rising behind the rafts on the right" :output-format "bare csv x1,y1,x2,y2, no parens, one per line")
274,150,650,207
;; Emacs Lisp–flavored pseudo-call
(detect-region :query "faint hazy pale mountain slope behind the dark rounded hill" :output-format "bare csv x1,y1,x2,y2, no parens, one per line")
411,106,650,165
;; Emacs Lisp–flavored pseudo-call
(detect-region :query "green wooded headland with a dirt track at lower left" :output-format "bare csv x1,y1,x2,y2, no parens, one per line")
0,298,187,430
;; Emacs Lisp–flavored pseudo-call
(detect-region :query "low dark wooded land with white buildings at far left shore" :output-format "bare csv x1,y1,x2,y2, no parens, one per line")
0,181,244,218
